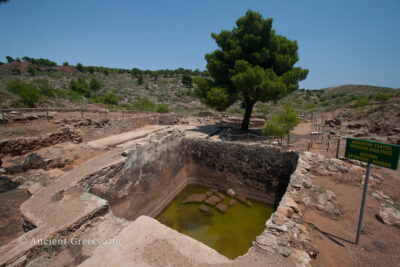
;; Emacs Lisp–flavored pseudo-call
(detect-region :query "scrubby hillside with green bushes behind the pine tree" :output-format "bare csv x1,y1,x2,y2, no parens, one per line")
0,62,400,118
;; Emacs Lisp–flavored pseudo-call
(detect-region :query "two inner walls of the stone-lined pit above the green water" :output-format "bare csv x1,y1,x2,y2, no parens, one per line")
80,131,298,258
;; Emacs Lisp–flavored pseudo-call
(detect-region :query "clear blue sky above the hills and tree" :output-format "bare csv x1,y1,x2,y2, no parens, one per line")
0,0,400,89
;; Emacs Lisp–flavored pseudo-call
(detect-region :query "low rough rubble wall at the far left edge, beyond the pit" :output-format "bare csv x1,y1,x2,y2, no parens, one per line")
0,127,82,157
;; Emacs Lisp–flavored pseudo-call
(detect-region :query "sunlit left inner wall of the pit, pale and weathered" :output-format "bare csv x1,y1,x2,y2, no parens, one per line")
82,132,187,220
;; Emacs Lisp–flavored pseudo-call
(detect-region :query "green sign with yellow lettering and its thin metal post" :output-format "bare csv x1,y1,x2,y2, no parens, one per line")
345,138,400,244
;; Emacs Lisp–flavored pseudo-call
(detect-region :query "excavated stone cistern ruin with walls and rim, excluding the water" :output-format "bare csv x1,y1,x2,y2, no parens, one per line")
0,129,322,266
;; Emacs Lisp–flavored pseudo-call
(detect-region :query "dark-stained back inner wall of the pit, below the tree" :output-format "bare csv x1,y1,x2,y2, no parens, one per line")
186,139,298,206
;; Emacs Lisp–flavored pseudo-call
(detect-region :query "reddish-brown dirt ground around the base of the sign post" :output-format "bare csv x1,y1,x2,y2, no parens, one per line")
304,165,400,266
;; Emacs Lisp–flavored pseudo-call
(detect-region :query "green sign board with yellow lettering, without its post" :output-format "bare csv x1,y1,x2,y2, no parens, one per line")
345,138,400,170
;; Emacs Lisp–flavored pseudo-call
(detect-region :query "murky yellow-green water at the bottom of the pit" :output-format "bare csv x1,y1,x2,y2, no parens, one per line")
156,185,274,259
